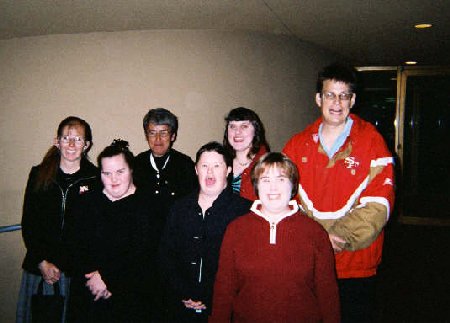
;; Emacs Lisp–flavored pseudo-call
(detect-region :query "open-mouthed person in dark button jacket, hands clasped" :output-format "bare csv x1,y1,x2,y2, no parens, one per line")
160,142,251,322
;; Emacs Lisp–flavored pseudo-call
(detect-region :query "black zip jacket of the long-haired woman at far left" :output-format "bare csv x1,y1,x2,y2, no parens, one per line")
22,159,100,275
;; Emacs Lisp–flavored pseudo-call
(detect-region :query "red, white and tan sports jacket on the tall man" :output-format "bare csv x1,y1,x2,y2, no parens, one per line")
283,115,394,278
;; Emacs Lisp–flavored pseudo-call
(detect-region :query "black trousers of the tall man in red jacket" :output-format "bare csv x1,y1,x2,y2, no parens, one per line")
338,276,377,323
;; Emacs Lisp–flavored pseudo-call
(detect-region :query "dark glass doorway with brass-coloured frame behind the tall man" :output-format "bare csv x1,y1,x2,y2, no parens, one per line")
353,67,450,225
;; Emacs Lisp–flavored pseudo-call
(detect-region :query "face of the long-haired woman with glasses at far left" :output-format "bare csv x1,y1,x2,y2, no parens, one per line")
55,126,90,163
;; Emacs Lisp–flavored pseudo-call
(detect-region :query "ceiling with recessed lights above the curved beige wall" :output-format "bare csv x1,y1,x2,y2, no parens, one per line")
0,0,450,66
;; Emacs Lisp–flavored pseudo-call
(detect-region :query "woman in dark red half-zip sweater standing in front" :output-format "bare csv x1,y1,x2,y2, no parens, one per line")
210,153,340,322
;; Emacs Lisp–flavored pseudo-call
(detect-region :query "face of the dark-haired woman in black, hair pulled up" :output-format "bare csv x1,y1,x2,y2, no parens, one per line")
101,154,133,201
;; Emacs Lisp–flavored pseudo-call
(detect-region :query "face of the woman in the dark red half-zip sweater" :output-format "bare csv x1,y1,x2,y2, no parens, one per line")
258,166,292,216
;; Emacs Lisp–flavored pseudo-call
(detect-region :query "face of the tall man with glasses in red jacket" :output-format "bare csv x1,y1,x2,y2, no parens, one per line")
316,80,355,126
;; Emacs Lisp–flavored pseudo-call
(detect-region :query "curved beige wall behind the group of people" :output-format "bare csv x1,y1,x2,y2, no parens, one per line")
0,30,334,317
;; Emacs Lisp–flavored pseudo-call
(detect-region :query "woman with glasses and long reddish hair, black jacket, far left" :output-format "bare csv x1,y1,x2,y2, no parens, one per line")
16,116,98,322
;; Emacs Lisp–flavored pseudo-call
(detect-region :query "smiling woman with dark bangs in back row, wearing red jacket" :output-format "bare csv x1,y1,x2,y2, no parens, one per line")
223,107,270,201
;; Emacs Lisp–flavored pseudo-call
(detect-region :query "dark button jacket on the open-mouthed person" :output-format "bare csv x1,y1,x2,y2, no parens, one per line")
160,188,251,311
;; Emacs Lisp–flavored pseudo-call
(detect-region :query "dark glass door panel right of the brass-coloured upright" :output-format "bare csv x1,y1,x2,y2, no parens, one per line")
401,71,450,220
